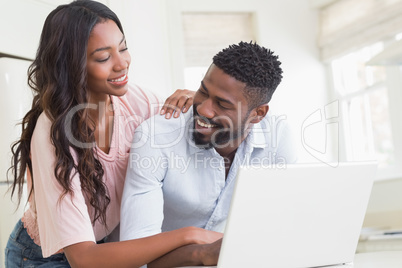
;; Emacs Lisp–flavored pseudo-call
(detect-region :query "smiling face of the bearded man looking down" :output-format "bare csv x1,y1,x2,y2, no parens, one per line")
193,64,254,148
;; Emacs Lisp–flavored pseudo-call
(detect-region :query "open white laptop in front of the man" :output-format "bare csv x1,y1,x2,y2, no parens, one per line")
184,162,377,268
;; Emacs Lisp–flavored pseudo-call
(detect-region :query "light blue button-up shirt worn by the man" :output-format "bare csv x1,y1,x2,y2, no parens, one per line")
120,111,296,240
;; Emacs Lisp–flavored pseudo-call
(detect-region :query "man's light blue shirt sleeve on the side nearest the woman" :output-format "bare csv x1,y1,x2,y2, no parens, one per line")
120,121,165,240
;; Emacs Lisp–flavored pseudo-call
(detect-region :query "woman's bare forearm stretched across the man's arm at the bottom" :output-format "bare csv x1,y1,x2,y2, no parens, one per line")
64,227,222,267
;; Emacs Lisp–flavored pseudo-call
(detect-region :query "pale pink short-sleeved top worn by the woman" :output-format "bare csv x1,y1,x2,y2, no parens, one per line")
22,85,161,257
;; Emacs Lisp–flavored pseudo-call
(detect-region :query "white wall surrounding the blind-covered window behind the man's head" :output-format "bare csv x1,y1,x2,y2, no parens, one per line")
114,0,336,162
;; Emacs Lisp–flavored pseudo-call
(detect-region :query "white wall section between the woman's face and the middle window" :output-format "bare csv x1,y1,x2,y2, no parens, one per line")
109,0,173,96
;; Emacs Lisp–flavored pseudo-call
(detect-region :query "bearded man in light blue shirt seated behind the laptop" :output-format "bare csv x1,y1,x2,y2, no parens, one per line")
120,42,296,267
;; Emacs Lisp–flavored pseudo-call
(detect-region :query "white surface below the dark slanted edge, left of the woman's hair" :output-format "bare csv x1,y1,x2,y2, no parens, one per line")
0,58,32,267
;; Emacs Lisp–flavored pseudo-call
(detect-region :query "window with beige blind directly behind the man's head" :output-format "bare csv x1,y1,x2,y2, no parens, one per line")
182,12,256,89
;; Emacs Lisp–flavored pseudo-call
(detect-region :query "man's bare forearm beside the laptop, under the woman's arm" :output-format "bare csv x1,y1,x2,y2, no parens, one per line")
148,238,222,268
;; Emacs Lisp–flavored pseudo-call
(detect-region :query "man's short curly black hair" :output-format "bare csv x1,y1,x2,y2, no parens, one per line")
213,42,282,110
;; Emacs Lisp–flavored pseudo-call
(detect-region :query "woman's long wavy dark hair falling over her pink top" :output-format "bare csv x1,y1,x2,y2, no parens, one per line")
10,0,123,224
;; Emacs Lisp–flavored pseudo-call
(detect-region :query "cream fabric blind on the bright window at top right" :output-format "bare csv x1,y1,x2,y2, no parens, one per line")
318,0,402,61
